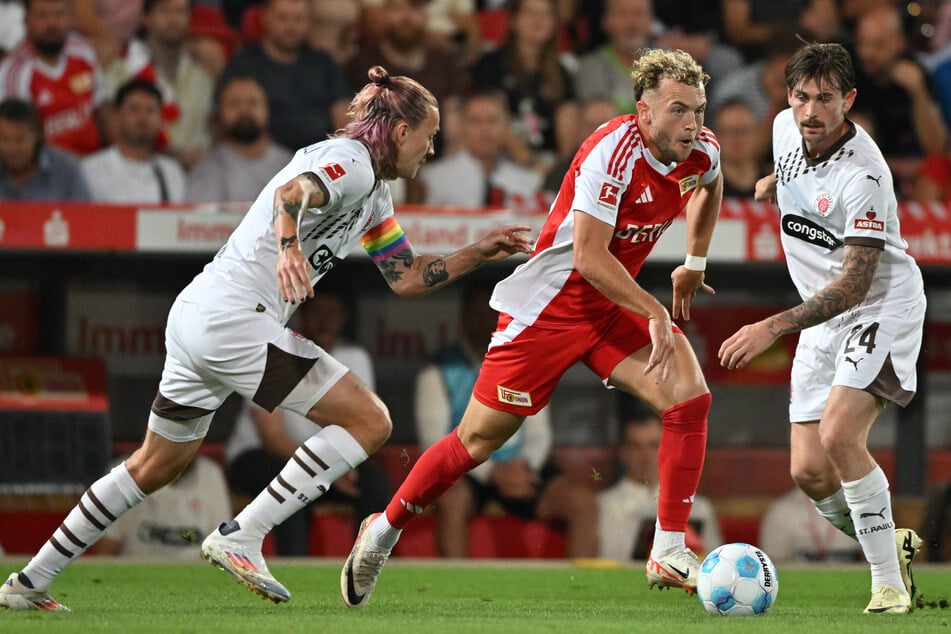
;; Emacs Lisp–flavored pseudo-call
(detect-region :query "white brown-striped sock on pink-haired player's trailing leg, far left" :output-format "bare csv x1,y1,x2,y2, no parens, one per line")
20,462,145,591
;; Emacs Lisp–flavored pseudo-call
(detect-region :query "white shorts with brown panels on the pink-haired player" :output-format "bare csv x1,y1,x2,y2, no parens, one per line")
149,299,347,442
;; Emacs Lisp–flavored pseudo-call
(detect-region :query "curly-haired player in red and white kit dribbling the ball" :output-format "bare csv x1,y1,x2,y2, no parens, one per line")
340,50,722,607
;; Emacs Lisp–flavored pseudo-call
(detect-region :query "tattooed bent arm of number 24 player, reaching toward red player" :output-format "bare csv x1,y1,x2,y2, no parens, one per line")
718,244,882,370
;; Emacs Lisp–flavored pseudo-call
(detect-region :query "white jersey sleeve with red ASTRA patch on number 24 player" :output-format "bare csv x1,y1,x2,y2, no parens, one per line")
842,168,891,249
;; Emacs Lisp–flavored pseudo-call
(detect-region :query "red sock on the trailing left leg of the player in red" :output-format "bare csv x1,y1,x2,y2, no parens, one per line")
386,430,479,528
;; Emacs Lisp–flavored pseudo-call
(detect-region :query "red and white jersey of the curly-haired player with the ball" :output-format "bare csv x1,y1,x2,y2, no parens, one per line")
491,115,720,328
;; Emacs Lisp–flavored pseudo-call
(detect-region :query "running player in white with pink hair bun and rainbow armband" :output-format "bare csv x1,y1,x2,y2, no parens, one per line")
0,66,531,610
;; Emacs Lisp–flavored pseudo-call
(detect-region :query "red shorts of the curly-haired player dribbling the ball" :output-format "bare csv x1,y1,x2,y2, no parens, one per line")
472,307,681,416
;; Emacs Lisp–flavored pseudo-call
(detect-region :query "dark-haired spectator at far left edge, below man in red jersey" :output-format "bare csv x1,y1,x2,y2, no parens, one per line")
0,99,90,200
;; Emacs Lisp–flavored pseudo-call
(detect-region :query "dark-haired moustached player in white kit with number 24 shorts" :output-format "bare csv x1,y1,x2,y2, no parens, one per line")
719,44,926,614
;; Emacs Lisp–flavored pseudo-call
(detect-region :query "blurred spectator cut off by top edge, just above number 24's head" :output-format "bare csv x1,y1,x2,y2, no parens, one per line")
722,0,840,62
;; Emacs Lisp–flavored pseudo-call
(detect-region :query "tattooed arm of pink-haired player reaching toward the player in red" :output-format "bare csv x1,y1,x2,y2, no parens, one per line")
364,221,533,297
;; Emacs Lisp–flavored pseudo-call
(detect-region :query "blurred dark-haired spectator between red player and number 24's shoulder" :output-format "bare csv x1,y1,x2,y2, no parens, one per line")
711,98,768,200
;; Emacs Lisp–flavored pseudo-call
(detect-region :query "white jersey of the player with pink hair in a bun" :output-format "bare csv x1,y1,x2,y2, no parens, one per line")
180,138,393,323
